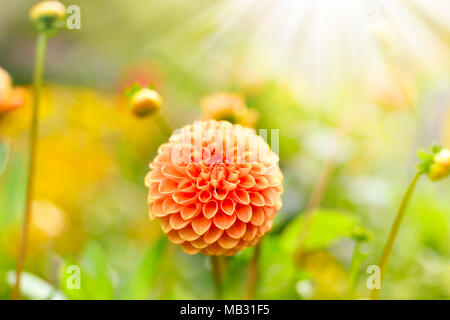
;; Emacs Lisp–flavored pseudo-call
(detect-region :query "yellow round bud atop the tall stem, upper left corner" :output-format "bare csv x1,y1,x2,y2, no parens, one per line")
30,0,66,31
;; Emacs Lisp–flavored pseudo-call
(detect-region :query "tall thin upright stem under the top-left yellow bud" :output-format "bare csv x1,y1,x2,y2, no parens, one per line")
12,32,47,299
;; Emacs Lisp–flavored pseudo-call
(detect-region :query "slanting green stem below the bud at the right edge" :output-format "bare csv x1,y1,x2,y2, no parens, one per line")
370,172,423,300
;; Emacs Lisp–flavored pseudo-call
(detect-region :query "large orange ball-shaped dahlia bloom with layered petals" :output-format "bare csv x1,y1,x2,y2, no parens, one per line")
145,120,283,255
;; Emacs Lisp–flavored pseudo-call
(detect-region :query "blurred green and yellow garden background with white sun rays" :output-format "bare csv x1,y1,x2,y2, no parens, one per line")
0,0,450,299
